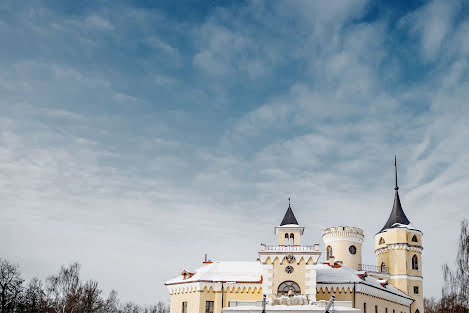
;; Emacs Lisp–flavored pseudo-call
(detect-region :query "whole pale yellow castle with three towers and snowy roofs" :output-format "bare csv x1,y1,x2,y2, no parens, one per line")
165,163,424,313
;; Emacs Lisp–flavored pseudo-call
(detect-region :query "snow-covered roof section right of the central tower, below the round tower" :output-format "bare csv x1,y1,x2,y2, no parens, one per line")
314,264,412,299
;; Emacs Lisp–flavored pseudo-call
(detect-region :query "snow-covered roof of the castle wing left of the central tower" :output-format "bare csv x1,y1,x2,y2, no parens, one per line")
165,261,262,285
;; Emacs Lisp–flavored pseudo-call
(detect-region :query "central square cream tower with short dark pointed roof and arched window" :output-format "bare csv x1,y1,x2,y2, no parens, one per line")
259,199,321,300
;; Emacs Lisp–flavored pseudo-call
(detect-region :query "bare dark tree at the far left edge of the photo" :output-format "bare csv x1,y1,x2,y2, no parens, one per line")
0,259,23,313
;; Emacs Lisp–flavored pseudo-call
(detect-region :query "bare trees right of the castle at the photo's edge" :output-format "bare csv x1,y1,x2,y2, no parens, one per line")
424,220,469,313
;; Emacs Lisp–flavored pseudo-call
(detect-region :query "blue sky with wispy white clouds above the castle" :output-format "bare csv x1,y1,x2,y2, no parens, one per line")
0,0,469,303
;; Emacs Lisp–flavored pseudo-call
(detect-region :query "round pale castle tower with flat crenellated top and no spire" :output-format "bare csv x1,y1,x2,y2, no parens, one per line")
322,226,364,270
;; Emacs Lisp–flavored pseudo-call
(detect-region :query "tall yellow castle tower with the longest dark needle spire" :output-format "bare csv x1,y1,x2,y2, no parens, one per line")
375,158,424,313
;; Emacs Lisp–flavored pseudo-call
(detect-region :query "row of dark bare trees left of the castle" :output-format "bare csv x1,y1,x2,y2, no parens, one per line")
0,258,169,313
